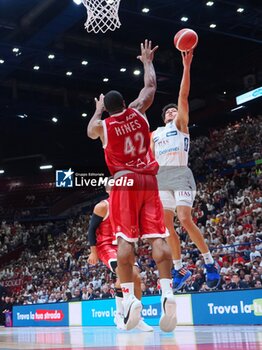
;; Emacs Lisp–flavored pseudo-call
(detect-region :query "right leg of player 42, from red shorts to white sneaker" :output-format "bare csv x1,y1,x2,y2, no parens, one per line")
140,176,177,332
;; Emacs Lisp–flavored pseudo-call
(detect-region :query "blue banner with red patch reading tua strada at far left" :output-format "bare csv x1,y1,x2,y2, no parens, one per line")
13,303,69,327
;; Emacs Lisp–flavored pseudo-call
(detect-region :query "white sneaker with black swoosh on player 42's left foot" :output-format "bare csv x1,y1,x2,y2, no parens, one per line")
123,295,142,331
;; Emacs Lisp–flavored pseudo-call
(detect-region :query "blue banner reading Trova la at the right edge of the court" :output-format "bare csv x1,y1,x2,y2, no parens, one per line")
192,289,262,325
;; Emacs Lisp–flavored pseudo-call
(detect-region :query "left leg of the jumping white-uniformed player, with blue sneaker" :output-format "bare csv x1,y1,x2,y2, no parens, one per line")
159,191,192,291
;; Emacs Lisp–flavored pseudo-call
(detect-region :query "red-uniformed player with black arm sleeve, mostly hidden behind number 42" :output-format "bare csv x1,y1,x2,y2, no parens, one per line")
87,193,153,332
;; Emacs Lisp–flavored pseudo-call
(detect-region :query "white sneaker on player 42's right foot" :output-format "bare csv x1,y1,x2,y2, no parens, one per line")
159,293,177,332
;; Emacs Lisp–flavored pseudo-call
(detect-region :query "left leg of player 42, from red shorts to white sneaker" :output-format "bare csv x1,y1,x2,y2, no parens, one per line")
110,174,142,330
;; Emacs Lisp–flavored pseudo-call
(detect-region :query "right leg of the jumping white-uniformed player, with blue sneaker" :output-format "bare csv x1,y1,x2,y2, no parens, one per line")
176,194,220,288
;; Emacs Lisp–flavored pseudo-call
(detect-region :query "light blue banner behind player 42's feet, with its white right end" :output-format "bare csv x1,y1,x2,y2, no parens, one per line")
82,294,193,326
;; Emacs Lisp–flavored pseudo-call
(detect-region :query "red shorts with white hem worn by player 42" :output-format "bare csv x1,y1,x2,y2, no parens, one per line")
110,172,169,242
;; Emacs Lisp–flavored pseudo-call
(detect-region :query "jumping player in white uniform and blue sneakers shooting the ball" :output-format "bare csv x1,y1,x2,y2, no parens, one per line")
151,51,220,290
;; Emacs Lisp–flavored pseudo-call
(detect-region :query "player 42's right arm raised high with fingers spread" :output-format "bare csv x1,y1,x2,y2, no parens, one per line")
129,40,158,113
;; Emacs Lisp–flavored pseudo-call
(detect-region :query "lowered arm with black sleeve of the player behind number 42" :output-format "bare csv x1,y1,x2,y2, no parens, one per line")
87,201,108,265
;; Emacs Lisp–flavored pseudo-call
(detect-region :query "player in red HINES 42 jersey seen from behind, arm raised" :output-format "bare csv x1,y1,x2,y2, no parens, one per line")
87,40,176,332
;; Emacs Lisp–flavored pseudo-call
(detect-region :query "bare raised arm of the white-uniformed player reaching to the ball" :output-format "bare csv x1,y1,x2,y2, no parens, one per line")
176,50,193,133
